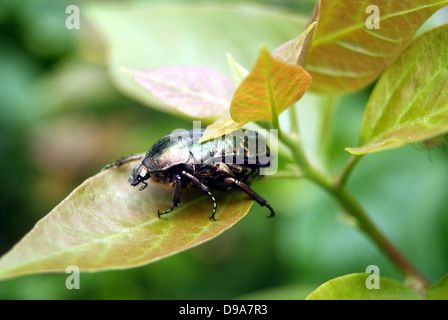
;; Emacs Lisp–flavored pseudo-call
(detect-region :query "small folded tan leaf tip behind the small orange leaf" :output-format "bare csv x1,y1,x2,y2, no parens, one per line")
272,21,317,65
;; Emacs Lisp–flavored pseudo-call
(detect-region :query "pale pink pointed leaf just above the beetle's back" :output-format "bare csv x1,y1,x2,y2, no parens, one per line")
126,66,235,119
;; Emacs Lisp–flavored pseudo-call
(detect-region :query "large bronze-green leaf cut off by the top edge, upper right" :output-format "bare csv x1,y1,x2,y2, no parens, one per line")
306,0,448,94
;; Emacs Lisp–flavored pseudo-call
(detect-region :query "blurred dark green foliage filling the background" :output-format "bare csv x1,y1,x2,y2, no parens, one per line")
0,0,448,299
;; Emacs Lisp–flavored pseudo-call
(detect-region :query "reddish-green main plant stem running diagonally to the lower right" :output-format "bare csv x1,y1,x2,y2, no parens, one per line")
278,130,429,288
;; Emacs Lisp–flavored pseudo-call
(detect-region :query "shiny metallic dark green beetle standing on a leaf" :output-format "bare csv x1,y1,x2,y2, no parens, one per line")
103,129,275,221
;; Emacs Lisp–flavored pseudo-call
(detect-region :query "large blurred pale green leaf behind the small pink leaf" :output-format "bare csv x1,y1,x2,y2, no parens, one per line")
80,1,307,115
